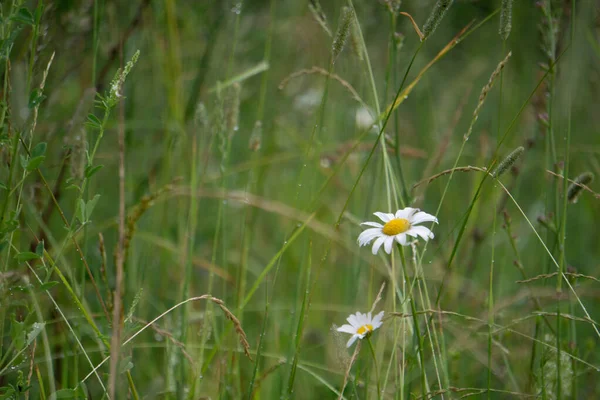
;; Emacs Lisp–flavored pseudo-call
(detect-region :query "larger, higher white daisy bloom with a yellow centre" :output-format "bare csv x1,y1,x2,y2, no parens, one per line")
358,207,438,254
